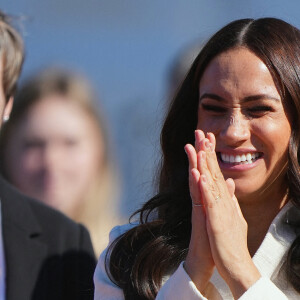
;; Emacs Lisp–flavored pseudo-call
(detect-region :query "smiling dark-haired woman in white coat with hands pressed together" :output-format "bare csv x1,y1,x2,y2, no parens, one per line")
94,18,300,300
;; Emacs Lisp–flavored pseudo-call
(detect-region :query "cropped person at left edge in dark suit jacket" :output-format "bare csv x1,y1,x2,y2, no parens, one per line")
0,11,96,300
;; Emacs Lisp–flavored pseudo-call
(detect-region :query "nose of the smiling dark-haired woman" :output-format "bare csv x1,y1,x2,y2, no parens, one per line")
219,113,250,145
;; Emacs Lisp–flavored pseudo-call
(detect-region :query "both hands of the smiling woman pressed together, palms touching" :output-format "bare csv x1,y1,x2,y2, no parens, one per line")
185,130,261,298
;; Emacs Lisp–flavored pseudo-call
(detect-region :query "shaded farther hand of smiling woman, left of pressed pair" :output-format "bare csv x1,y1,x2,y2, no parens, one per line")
184,130,215,292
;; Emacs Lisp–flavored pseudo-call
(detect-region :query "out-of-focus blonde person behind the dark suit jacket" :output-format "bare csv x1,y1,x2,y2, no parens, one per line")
0,67,119,255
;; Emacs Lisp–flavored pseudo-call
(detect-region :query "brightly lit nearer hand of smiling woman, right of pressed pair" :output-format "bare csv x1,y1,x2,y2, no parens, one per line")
198,133,261,298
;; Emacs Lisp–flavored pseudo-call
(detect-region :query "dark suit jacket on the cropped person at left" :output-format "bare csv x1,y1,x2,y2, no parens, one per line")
0,177,96,300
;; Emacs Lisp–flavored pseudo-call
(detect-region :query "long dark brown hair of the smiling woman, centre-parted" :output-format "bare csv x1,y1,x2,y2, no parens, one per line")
106,18,300,299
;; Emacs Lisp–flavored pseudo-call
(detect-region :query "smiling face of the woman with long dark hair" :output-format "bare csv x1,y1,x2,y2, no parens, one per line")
197,48,291,201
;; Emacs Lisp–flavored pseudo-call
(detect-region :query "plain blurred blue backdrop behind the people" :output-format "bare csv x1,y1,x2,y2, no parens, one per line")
0,0,300,216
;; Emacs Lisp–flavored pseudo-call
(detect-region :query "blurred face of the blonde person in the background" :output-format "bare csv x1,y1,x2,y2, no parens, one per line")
6,95,103,216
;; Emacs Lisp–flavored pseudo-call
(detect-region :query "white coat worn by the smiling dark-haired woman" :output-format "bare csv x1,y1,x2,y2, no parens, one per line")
94,203,300,300
